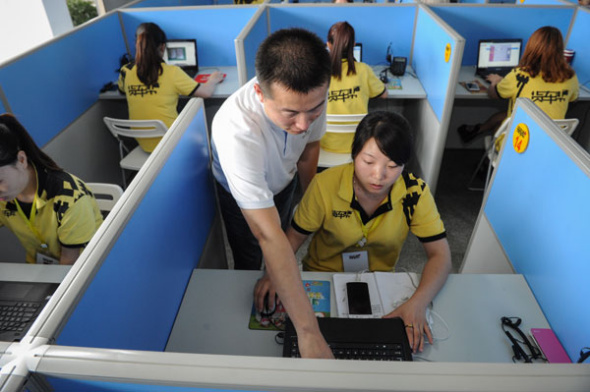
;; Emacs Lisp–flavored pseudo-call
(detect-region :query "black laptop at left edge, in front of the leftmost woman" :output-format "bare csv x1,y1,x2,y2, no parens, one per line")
0,281,59,342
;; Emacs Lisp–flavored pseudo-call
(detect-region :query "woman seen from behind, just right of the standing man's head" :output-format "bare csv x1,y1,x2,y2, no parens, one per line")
320,22,387,153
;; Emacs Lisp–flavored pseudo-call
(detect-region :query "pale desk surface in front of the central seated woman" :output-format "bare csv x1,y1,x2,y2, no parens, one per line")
166,269,548,363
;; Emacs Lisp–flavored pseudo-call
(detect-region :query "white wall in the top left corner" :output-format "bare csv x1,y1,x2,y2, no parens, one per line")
0,0,73,63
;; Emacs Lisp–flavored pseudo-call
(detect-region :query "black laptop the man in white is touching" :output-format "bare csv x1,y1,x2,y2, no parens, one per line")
283,317,412,361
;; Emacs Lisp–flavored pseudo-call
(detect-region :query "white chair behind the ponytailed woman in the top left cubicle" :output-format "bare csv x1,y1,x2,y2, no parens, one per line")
103,117,168,188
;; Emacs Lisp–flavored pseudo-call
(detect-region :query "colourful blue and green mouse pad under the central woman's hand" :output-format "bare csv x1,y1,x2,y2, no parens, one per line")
248,280,331,331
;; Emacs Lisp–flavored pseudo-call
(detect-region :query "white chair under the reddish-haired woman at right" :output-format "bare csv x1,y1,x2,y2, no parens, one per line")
467,117,580,191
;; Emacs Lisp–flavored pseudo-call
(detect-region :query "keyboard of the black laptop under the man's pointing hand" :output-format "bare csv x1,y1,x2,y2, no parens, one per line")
291,339,404,361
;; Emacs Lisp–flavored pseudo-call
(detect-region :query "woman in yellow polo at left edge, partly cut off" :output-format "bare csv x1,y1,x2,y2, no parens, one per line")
0,114,102,264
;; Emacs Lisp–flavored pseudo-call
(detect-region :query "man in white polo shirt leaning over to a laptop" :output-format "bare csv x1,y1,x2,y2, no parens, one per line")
211,28,333,358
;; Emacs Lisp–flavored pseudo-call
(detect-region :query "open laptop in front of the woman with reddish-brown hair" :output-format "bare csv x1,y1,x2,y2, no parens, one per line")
475,39,522,79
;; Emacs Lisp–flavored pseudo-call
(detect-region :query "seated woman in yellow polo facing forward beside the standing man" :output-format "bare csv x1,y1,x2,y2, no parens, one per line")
255,111,451,352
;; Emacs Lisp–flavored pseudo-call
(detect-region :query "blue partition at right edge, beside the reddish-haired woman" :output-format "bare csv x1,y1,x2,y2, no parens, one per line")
566,7,590,88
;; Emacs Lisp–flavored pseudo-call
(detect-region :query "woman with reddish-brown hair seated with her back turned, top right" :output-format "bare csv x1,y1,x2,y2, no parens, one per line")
458,26,580,143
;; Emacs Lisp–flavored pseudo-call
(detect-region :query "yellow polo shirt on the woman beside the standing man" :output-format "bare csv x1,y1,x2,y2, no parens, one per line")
292,163,446,272
